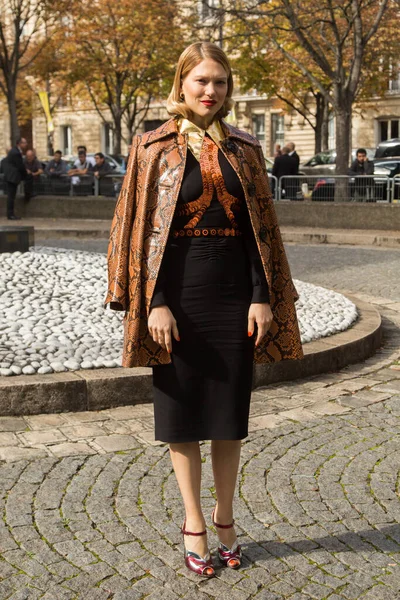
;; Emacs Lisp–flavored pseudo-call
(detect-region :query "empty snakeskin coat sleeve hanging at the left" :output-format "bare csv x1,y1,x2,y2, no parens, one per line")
104,136,140,311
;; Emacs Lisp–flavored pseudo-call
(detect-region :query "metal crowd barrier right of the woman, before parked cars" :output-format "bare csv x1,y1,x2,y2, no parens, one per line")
277,175,392,202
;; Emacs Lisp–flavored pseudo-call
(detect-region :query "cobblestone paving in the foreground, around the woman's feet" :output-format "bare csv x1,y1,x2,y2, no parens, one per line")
0,295,400,600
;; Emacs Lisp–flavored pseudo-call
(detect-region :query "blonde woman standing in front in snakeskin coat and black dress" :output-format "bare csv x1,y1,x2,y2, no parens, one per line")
106,43,302,577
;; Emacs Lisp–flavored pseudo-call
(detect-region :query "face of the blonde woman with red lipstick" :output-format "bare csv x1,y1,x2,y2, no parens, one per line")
181,58,228,129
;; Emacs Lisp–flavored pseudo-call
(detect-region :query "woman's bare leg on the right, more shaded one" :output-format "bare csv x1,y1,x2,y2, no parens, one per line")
211,440,242,548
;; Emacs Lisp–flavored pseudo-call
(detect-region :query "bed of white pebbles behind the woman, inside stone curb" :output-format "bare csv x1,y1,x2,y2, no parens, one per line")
0,247,357,377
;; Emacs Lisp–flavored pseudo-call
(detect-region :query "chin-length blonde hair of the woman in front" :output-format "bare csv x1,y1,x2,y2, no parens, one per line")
167,42,234,119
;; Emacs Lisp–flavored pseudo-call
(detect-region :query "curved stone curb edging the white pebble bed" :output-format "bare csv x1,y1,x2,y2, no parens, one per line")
0,296,382,416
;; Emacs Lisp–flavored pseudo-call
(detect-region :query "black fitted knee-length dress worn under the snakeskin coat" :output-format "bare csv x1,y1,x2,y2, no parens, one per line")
151,145,269,443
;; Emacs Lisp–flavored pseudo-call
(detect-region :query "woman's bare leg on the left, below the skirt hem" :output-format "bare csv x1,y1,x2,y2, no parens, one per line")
170,442,208,557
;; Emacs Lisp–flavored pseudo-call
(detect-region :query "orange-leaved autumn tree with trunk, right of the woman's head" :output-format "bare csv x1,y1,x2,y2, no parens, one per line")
224,0,399,173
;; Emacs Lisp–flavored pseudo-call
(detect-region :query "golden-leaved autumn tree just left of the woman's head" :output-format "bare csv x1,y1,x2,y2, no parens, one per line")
64,0,184,153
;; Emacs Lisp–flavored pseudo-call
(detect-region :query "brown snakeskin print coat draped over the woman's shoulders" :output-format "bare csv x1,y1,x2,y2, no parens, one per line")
105,119,303,367
